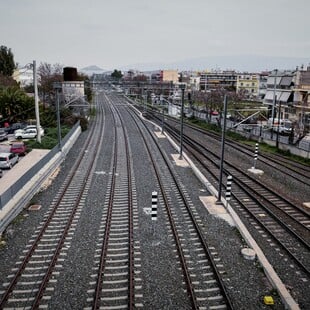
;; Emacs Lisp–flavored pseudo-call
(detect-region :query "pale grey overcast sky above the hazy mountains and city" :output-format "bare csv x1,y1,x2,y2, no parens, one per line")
0,0,310,69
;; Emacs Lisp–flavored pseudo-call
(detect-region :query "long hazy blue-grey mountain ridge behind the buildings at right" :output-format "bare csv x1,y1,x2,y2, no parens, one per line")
122,55,310,72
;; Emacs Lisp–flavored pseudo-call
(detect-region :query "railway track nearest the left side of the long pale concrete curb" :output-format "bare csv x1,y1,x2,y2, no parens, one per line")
119,100,233,309
